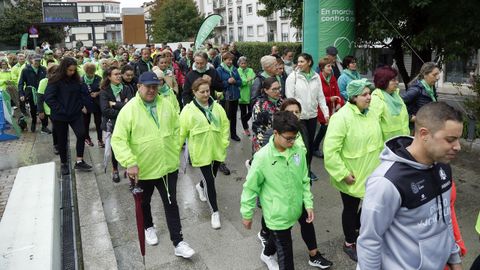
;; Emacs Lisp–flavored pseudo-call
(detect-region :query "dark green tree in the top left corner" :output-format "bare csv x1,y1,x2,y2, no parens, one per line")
0,0,65,46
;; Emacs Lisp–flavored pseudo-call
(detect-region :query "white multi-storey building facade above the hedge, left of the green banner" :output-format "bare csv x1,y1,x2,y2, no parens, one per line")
195,0,302,44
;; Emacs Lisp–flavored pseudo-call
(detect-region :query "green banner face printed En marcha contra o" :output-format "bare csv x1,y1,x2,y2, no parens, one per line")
318,0,355,60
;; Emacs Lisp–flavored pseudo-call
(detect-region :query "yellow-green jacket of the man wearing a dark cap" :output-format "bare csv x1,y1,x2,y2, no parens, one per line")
112,93,180,180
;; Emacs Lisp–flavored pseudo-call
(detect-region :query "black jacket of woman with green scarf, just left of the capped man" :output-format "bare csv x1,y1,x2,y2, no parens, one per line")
100,86,135,131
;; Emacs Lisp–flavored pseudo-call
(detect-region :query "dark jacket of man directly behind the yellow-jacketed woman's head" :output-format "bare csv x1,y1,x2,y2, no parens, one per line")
182,67,223,106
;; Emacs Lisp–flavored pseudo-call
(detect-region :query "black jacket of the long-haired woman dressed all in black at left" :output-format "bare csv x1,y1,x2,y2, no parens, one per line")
45,80,87,122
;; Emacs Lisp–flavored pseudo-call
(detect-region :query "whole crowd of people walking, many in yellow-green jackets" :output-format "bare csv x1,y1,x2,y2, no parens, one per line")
0,43,476,269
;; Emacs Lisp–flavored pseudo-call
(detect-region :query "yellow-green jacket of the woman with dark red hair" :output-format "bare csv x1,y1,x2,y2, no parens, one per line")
369,88,410,142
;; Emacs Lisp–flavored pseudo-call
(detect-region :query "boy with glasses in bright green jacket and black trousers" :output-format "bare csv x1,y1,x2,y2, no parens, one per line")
240,111,314,269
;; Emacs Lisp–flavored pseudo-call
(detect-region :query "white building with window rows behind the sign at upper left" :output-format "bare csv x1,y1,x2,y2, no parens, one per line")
65,0,122,47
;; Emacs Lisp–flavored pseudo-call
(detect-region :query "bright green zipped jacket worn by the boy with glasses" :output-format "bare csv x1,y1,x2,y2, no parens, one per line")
240,136,313,230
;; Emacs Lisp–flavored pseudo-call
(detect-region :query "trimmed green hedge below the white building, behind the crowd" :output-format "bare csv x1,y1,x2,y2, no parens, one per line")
235,42,302,72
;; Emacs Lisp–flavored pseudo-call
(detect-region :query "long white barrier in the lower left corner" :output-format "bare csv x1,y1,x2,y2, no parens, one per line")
0,162,62,270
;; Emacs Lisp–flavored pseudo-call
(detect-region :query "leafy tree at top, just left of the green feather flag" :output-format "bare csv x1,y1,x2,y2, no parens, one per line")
152,0,203,42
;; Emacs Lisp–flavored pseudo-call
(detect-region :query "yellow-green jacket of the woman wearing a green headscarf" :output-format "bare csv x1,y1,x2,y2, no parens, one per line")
323,102,383,198
